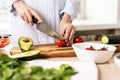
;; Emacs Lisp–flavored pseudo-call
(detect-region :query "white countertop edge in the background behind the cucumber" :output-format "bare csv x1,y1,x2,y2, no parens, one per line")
72,19,120,31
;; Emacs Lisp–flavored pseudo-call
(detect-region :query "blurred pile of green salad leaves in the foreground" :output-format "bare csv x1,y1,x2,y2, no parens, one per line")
0,54,77,80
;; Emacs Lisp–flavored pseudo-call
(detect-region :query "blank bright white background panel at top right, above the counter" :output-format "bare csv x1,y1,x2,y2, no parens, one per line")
86,0,119,21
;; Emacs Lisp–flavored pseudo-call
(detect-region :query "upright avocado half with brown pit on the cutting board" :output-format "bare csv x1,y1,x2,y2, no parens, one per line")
18,37,33,52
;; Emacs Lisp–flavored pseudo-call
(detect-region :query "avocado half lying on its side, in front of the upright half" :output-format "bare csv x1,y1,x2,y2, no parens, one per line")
10,50,40,61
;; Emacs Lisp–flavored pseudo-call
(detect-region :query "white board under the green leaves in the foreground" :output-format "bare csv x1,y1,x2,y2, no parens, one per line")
28,60,98,80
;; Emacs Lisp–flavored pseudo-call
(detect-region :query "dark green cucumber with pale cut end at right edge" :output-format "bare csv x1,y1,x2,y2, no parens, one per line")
101,35,120,44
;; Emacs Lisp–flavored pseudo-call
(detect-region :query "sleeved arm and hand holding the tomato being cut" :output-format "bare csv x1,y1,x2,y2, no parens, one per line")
60,0,80,42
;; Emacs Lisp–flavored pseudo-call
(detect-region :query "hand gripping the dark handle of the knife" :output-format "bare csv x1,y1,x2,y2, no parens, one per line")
13,1,42,25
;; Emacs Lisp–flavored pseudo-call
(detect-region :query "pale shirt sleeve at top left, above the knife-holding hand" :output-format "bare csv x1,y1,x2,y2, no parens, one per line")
0,0,17,11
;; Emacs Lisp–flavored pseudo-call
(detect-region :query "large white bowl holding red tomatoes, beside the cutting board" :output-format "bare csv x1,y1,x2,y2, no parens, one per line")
72,42,116,63
